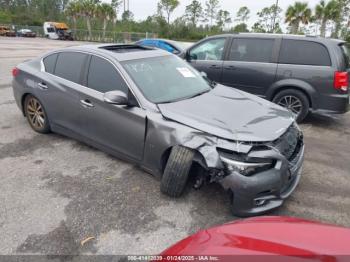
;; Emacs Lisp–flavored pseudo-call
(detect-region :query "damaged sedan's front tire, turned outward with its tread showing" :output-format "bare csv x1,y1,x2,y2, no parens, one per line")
160,146,194,197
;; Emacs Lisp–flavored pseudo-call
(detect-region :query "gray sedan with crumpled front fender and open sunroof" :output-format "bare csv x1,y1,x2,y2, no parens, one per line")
13,45,304,216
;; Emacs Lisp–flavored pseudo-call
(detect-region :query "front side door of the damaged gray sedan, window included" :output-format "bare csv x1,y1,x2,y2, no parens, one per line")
79,55,146,161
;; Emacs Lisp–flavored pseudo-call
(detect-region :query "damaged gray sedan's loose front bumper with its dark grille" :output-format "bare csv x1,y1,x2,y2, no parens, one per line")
218,126,304,217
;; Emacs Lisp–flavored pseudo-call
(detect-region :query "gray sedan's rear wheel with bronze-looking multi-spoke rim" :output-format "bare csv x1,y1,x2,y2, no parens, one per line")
24,95,50,134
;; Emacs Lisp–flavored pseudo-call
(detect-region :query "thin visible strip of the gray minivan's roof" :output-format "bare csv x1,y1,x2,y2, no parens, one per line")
210,33,345,44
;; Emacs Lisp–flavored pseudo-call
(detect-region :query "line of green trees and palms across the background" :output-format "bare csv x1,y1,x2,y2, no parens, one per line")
0,0,350,40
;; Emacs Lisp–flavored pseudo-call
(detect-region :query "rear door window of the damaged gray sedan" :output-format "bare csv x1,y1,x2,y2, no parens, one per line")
55,52,87,83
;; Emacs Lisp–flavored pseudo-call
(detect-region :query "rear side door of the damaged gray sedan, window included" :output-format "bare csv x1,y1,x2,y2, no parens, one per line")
37,52,88,133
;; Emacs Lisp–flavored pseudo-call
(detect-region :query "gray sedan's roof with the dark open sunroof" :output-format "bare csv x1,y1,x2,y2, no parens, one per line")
56,44,171,62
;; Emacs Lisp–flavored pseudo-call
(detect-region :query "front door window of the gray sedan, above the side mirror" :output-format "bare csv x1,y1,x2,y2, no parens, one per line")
87,56,128,94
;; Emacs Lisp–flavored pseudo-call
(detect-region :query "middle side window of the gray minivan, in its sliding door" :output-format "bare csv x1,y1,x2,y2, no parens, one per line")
229,38,275,63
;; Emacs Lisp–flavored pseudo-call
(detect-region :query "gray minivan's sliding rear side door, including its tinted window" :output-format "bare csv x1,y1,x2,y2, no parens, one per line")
222,37,278,96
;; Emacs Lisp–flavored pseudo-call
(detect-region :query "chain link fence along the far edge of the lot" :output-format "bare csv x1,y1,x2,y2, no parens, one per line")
4,25,157,43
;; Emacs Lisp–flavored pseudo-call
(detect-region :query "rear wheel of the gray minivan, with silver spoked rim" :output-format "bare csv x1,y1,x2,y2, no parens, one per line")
272,89,310,123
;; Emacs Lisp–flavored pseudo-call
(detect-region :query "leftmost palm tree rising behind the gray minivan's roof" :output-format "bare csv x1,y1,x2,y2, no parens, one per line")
286,2,312,34
